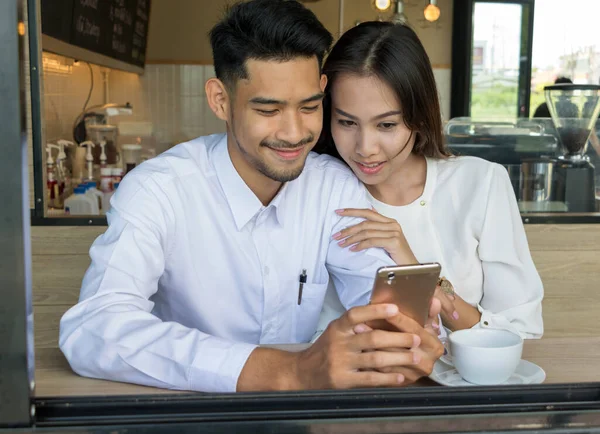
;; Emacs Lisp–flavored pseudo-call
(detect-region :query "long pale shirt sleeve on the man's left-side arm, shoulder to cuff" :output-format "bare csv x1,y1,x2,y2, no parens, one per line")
59,174,255,392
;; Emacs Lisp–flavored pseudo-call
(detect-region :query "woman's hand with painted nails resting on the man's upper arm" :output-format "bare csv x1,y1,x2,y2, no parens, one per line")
333,208,419,265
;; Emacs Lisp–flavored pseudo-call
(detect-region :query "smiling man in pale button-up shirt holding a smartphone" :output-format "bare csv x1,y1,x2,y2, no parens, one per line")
60,0,443,392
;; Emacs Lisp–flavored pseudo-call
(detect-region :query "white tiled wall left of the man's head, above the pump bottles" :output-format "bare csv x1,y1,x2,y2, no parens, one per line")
44,55,225,152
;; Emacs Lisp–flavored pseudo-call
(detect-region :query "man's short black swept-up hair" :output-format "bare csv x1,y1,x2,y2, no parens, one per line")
210,0,333,89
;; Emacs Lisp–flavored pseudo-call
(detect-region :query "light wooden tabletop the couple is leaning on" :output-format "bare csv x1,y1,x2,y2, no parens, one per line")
35,337,600,397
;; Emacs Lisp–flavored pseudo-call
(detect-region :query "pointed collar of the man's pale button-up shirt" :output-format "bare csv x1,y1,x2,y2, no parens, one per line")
213,134,288,231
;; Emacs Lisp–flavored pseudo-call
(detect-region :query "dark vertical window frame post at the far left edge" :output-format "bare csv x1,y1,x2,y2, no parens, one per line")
0,0,33,426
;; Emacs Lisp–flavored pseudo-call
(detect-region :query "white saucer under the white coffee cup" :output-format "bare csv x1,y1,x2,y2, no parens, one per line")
429,357,546,387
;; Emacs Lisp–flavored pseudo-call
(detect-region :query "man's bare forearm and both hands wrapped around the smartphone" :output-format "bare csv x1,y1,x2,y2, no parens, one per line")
237,299,443,392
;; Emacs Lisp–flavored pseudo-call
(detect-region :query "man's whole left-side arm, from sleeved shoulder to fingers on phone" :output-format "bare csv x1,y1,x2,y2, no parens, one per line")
59,165,440,392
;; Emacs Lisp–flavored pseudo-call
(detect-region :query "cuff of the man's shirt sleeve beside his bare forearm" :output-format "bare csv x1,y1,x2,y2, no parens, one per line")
189,338,258,393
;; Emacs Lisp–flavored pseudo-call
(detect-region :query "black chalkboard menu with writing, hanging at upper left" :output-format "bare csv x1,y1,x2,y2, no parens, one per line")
41,0,150,67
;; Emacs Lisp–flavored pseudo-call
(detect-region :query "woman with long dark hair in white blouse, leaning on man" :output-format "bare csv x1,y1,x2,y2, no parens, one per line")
319,22,543,338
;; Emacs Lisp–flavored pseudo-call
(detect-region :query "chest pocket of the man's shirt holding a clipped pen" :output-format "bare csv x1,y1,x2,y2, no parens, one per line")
294,283,327,343
